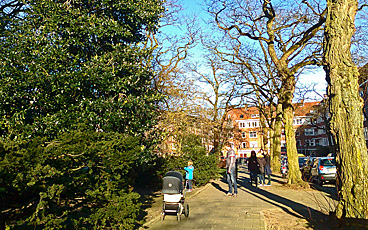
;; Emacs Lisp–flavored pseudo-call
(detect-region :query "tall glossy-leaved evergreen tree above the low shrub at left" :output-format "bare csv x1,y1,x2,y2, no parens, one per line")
0,0,163,140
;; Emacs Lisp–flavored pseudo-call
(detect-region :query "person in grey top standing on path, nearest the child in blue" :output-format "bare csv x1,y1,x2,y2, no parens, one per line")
226,148,238,197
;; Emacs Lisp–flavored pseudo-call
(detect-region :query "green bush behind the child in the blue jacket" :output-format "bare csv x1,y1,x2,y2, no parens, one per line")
162,134,218,186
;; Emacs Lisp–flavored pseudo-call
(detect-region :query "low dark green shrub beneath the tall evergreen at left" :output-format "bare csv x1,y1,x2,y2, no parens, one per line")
0,130,144,229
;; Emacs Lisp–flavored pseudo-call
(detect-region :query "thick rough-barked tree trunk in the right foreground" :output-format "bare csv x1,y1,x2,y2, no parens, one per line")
324,0,368,219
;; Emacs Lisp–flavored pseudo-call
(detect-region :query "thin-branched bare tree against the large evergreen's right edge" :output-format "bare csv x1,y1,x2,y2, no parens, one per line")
142,0,201,153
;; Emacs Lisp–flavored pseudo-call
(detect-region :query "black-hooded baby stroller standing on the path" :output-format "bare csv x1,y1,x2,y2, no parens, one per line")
161,171,189,221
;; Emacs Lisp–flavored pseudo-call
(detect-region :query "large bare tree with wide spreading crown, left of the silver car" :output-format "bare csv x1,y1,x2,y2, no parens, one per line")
209,0,326,184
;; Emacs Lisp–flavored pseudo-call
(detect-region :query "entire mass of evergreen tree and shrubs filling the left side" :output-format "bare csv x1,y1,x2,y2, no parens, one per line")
0,0,163,229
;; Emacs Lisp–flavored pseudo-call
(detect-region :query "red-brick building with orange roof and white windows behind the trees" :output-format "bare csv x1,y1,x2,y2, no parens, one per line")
227,102,331,157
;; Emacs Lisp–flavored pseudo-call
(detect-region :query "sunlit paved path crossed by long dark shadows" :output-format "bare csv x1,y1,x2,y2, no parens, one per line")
142,166,334,230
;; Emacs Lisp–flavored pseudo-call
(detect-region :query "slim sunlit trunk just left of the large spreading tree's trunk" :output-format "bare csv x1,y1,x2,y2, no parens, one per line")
271,103,282,171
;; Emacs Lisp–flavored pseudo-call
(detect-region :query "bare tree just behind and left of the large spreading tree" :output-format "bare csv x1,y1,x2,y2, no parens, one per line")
206,32,282,170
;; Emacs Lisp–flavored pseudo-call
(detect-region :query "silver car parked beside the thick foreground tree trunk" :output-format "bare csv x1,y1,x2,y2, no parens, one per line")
311,157,336,186
